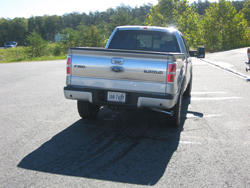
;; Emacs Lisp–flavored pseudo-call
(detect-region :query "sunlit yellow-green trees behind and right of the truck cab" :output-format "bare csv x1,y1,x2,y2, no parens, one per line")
146,0,250,51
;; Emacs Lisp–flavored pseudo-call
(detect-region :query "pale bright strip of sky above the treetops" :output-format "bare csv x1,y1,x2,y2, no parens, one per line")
0,0,158,19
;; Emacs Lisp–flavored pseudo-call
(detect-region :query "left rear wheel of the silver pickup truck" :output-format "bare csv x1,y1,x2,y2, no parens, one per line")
77,101,100,119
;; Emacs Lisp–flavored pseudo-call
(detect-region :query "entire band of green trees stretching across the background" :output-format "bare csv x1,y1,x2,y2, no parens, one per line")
0,0,250,55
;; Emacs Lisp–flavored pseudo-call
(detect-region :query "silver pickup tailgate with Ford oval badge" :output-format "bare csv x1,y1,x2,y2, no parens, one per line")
69,48,174,93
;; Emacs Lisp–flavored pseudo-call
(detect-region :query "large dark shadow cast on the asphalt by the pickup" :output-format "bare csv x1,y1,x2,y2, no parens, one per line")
18,99,196,185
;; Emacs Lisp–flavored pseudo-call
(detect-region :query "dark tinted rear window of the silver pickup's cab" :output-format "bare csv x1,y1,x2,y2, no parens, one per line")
109,30,180,52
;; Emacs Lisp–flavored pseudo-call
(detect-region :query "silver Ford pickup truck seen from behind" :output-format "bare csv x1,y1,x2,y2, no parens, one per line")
64,26,205,127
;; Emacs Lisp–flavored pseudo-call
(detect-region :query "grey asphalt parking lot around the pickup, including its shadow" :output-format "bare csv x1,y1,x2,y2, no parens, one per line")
0,49,250,188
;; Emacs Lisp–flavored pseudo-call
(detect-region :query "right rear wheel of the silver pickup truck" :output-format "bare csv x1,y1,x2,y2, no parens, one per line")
167,94,183,128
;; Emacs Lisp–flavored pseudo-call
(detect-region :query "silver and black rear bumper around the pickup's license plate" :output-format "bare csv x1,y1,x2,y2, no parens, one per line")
64,86,178,110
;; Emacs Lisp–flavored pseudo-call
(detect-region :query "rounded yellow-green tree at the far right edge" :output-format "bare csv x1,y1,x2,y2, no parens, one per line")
203,0,248,50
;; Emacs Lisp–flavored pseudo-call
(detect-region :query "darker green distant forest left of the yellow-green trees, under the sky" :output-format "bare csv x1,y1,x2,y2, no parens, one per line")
0,4,152,46
